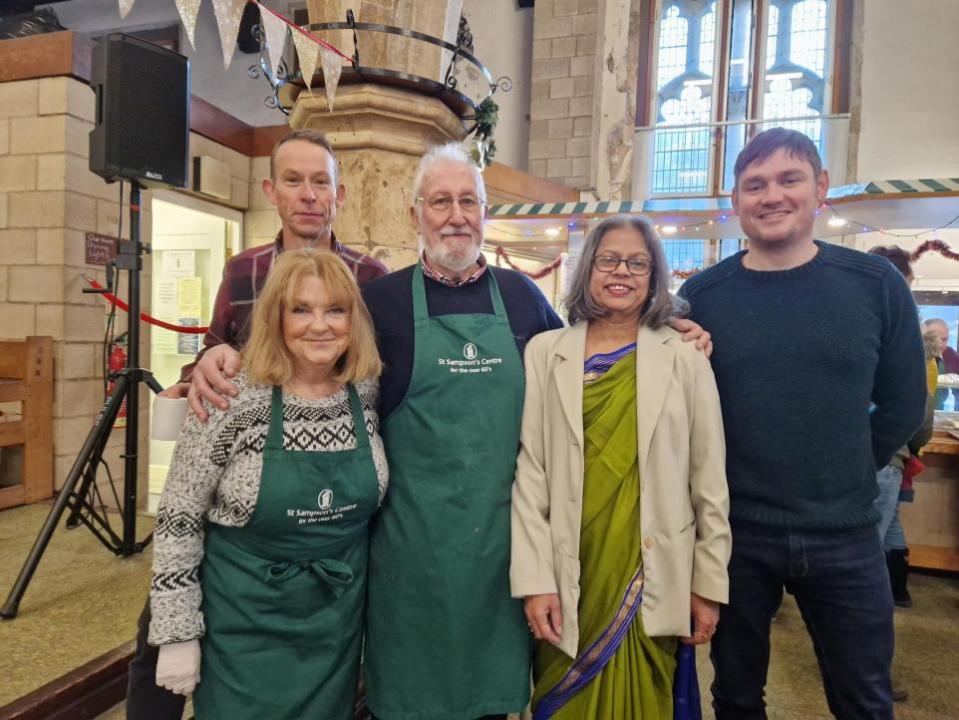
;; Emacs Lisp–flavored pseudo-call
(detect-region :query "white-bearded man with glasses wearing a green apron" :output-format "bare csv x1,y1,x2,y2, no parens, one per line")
363,145,562,720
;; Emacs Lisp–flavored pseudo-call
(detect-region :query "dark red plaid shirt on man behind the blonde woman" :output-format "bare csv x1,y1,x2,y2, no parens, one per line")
180,233,389,382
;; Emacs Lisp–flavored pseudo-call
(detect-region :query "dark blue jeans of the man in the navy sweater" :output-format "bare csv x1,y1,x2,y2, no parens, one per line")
710,522,893,720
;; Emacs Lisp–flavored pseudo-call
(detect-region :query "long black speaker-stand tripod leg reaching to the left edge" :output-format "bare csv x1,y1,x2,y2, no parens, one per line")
0,375,130,620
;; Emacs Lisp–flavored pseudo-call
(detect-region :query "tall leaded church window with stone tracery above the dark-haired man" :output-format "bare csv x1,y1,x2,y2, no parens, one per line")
637,0,850,196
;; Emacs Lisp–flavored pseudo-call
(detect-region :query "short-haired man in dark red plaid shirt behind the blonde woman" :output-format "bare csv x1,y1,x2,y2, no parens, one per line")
127,130,389,720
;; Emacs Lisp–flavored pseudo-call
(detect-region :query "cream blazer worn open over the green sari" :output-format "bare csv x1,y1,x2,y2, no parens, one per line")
510,322,732,657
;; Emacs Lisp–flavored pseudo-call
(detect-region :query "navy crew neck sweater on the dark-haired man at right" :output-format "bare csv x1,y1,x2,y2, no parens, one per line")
680,241,925,529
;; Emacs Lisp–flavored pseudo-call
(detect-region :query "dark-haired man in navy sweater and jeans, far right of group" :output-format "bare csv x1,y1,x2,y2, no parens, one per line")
681,128,925,720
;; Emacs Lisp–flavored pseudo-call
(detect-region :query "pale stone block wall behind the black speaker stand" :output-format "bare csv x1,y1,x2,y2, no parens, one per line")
0,77,256,506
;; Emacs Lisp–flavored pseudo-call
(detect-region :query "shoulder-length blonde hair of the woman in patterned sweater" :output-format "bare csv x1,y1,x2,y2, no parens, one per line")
241,249,383,385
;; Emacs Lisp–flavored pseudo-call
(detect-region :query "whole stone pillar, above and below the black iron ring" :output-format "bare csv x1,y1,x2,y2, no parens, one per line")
290,0,466,269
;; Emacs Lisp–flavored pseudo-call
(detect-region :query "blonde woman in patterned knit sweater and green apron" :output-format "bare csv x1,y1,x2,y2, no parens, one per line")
149,250,388,720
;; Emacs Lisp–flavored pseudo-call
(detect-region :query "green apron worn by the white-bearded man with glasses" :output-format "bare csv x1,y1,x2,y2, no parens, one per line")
364,266,531,720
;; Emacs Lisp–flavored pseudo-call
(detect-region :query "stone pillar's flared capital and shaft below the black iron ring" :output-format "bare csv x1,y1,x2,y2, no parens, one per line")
290,84,465,270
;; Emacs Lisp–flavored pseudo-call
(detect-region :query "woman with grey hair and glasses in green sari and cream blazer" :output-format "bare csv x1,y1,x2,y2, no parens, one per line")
510,216,731,720
